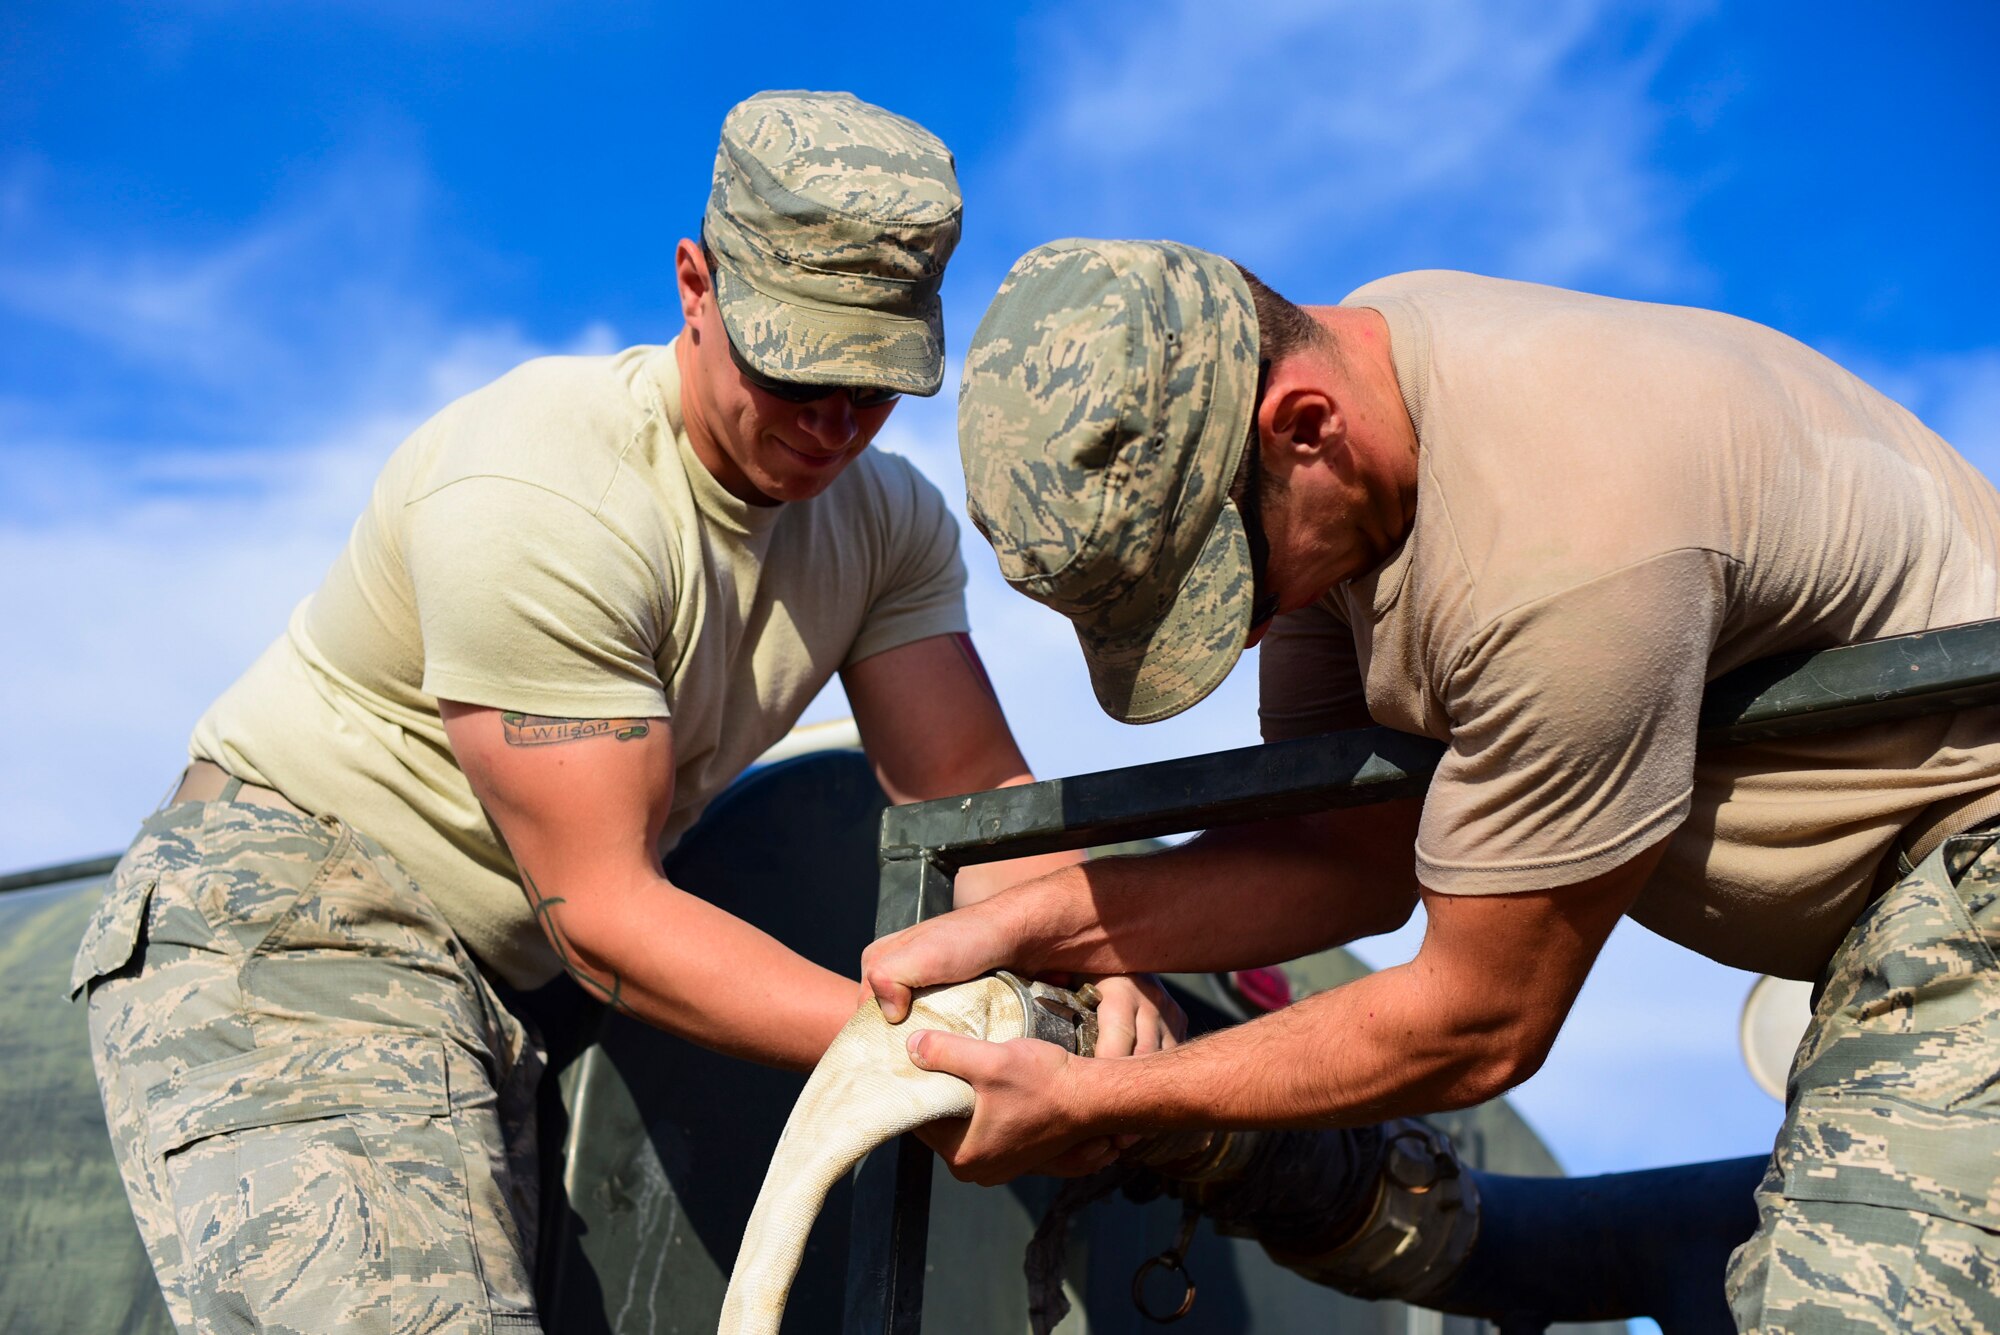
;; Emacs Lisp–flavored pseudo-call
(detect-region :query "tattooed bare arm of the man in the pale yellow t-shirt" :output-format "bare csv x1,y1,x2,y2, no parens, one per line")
440,701,854,1069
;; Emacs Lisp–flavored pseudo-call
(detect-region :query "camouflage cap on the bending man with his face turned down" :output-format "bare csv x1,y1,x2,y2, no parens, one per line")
958,240,1258,723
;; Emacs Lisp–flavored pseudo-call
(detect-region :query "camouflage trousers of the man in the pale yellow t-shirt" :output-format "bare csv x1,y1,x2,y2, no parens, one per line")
70,787,542,1335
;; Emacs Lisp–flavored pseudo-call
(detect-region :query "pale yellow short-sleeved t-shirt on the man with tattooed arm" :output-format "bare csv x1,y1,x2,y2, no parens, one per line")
192,346,966,985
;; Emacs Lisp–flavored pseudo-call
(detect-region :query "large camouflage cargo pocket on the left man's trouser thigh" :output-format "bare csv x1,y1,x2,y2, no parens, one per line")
148,1031,532,1335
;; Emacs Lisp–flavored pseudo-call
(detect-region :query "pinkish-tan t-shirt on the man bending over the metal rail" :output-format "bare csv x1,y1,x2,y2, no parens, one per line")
1262,272,2000,977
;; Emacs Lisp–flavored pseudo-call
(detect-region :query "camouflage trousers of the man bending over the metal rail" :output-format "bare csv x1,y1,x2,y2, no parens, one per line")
1728,829,2000,1335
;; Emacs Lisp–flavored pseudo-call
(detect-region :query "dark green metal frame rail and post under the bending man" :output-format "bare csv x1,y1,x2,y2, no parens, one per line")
842,622,2000,1335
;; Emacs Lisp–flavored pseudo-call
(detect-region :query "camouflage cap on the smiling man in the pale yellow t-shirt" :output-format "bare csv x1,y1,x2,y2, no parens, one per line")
702,92,962,394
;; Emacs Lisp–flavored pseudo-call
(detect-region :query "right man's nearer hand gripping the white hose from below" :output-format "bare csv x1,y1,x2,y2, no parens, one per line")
910,1029,1118,1187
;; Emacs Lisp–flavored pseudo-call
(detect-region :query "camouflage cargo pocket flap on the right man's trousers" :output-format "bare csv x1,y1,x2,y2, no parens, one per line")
1780,1093,2000,1231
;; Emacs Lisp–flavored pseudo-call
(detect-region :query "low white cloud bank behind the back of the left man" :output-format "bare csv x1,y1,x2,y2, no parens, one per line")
0,317,608,869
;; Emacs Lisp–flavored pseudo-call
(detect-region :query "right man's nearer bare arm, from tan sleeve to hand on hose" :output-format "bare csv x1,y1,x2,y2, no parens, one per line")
910,845,1660,1183
